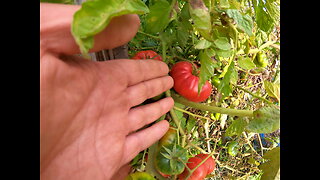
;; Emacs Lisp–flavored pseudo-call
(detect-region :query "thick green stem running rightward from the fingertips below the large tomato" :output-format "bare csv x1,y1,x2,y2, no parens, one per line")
171,92,253,117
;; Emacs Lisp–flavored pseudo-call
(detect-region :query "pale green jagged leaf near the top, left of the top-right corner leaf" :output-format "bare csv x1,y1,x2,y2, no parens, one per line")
226,9,253,36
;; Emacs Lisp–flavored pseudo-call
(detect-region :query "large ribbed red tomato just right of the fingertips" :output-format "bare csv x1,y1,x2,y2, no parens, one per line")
170,61,212,102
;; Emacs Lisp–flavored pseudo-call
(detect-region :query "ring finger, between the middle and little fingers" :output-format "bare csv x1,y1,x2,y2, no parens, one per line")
128,97,174,132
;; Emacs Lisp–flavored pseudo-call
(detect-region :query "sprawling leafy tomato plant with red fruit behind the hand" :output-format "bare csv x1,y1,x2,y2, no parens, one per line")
67,0,280,179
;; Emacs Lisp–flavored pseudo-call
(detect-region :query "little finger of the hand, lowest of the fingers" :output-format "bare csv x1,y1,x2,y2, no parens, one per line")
123,120,169,163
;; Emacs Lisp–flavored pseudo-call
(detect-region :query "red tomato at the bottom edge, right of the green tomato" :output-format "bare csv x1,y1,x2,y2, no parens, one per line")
178,157,208,180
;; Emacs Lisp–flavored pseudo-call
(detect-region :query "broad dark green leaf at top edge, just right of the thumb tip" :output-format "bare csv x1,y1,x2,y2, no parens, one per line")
145,0,176,34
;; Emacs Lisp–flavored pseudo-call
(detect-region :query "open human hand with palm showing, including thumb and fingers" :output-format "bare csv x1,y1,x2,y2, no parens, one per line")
40,3,174,180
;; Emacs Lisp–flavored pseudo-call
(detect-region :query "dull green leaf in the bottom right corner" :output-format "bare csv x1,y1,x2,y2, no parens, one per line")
259,147,280,180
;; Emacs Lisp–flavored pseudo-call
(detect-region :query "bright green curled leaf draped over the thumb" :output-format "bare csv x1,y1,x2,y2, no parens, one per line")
71,0,149,54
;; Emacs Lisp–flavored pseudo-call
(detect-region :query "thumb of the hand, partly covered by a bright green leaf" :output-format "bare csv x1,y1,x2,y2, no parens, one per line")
40,3,140,55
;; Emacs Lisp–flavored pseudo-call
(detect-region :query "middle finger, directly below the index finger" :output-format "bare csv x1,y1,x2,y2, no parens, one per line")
127,76,173,107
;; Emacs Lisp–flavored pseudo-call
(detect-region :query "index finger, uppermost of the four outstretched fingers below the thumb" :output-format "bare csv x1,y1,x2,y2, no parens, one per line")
98,59,169,87
